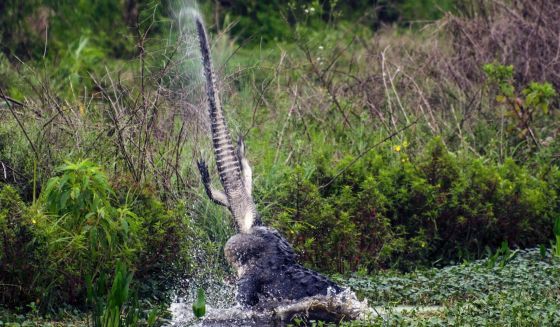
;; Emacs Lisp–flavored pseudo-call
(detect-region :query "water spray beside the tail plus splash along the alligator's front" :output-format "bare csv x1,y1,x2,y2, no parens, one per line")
169,1,375,326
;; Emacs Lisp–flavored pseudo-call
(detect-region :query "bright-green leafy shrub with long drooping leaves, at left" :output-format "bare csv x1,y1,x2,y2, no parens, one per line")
42,161,140,277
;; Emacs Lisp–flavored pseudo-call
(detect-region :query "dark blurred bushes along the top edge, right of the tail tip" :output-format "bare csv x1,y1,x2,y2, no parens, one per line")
212,0,455,45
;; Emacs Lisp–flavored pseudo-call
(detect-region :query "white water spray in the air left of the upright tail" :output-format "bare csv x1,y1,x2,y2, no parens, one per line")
164,0,235,326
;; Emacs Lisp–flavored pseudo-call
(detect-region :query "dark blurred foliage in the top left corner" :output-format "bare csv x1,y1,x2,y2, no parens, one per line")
0,0,167,60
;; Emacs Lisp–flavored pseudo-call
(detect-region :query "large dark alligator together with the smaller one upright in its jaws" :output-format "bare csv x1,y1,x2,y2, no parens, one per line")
195,17,350,319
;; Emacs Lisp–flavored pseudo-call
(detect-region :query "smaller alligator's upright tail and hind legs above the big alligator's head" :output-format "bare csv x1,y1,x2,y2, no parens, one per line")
196,17,257,233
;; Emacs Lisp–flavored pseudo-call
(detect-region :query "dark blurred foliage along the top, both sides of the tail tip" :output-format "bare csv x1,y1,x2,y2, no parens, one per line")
0,0,455,57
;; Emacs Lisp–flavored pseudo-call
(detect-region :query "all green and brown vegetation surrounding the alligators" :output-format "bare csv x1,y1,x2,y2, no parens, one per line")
0,0,560,326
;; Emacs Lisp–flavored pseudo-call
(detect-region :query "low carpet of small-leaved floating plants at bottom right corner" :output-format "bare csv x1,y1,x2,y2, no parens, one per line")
330,249,560,326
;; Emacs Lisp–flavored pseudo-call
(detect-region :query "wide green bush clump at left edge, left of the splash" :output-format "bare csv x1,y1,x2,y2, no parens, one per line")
0,160,192,309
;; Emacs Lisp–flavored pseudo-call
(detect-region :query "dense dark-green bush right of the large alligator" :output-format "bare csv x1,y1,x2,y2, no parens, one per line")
270,138,559,272
